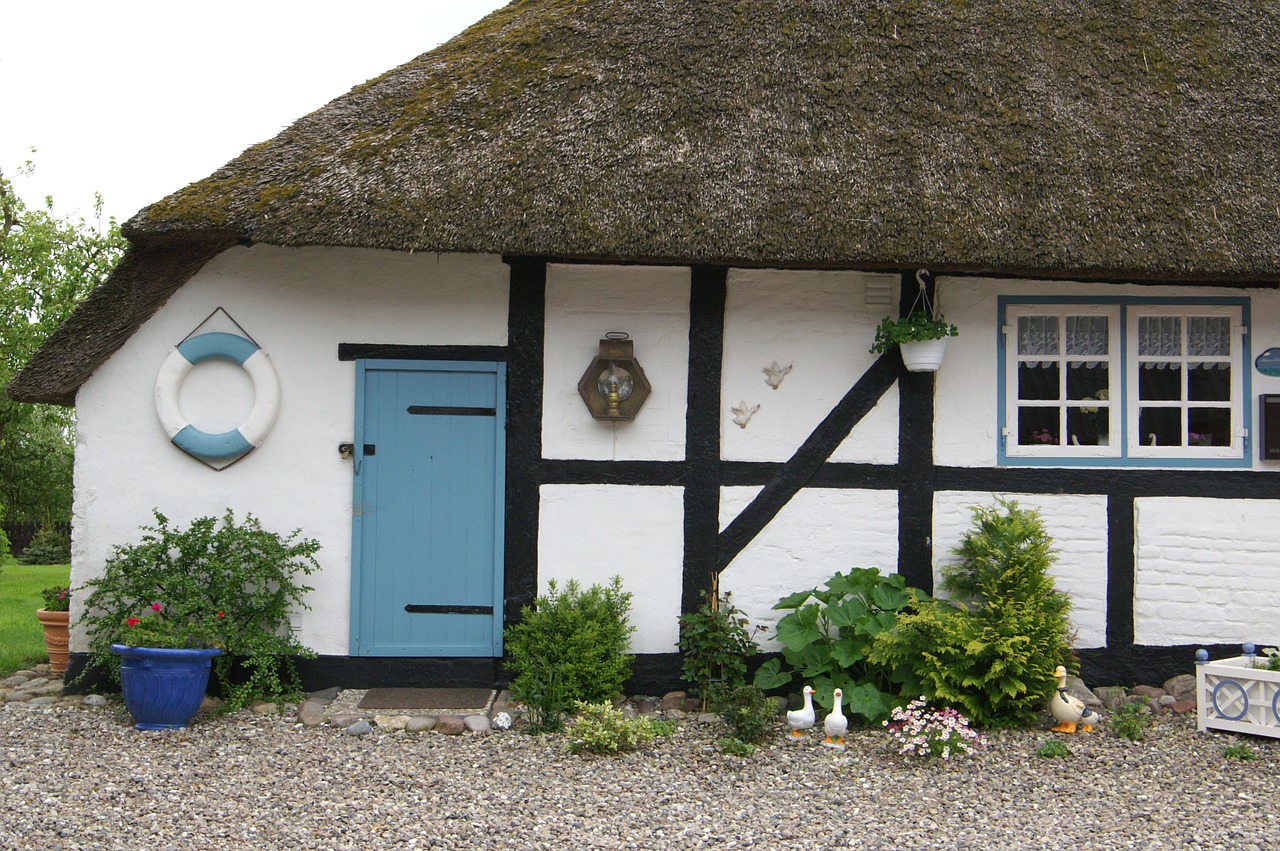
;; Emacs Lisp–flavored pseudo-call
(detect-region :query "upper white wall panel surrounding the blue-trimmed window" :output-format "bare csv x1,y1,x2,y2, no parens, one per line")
934,276,1280,470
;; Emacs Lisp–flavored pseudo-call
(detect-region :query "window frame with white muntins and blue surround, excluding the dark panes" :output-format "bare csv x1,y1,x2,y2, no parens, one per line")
1000,296,1253,467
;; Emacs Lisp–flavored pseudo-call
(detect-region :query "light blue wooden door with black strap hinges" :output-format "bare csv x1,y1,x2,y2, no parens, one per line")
351,361,506,656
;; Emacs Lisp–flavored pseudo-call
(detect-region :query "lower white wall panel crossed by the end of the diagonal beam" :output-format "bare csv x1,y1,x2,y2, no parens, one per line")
721,488,897,651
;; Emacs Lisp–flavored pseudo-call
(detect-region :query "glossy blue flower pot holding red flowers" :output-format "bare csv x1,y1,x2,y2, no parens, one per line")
111,644,221,729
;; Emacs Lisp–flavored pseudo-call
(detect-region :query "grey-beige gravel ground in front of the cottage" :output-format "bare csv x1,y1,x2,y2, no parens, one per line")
0,701,1280,851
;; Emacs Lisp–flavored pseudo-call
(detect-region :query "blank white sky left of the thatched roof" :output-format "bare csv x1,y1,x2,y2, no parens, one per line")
0,0,507,223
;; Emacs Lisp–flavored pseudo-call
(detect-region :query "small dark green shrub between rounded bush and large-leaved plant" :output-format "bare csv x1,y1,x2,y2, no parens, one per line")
680,593,760,709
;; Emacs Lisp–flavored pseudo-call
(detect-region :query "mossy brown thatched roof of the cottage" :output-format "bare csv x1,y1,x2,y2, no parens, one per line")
14,0,1280,401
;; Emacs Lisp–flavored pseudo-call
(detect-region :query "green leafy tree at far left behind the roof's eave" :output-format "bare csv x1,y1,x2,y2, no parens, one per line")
0,163,124,521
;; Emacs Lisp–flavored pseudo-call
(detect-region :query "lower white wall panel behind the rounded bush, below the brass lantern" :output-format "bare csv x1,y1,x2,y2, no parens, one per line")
538,485,685,653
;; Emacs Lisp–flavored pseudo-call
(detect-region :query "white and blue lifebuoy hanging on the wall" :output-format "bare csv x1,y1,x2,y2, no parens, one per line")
156,331,280,461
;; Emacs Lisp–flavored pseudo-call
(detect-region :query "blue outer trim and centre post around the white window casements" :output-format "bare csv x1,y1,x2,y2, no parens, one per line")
996,296,1256,468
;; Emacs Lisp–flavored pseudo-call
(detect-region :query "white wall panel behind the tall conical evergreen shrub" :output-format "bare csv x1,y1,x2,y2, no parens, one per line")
933,491,1107,648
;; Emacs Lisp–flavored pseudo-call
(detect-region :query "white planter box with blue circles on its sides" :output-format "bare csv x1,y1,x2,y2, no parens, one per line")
1196,651,1280,738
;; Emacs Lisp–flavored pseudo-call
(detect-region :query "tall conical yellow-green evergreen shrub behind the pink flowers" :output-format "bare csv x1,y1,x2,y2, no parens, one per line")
868,500,1074,727
